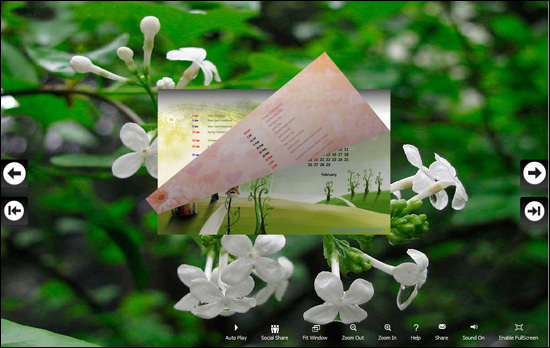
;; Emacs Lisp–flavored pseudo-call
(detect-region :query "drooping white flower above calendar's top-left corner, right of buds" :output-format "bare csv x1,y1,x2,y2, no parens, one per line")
166,47,221,88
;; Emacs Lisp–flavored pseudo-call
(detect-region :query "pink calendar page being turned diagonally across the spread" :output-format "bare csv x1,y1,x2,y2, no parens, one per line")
147,53,389,214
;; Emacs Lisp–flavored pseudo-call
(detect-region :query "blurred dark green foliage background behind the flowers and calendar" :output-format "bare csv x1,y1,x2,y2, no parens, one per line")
1,1,548,346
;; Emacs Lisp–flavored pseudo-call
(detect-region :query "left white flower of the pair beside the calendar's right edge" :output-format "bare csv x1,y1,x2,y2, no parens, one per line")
403,145,449,210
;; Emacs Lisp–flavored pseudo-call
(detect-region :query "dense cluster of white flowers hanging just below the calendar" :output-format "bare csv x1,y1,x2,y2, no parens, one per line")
174,235,294,319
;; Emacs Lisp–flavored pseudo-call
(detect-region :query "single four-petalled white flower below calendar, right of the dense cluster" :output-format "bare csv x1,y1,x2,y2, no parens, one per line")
304,272,374,325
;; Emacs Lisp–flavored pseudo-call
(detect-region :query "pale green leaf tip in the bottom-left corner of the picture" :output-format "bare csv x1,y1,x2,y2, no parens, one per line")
2,319,99,347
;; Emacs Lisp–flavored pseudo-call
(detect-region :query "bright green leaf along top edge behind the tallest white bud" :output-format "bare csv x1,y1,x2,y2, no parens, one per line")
75,1,255,49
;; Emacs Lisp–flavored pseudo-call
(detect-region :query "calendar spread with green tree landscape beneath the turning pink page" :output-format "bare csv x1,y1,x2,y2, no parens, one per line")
158,90,390,235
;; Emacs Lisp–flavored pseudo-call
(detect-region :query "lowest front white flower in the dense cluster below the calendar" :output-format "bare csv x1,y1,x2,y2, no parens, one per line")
190,271,256,319
